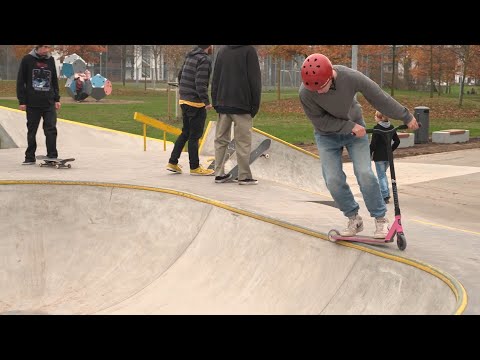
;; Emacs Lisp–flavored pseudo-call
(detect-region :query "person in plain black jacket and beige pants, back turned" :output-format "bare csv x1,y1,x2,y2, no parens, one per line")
212,45,262,185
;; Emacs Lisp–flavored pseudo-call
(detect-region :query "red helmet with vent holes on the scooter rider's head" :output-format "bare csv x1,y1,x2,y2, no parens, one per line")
302,54,333,91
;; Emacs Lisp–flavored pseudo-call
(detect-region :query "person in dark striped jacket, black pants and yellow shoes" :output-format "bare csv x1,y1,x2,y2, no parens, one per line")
167,45,213,175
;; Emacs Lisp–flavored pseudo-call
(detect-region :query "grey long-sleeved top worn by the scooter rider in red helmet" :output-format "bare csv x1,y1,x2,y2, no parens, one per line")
299,65,413,134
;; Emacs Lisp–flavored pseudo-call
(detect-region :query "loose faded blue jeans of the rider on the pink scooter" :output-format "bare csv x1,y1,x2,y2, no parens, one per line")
315,132,387,217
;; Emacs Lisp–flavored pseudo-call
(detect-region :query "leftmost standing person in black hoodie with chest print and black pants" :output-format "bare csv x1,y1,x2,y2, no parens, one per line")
17,45,61,165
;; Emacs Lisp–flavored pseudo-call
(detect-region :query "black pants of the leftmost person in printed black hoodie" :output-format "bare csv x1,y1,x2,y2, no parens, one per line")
25,105,58,161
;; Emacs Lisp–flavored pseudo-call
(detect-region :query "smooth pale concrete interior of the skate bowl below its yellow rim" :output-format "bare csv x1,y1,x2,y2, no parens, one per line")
0,183,458,314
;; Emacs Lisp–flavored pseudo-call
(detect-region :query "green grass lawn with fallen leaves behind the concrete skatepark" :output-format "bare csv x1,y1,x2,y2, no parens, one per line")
0,81,480,144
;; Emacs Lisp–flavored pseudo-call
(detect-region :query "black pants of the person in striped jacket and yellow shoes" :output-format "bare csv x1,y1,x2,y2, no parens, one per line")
169,104,207,169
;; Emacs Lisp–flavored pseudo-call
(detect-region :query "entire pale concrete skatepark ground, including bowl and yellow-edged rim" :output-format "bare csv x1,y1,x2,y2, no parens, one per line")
0,107,480,315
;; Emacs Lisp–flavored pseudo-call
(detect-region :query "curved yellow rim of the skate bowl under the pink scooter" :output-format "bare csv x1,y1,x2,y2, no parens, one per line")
0,180,468,315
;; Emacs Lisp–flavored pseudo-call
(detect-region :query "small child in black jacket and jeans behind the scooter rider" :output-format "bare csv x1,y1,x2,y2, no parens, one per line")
370,111,400,204
